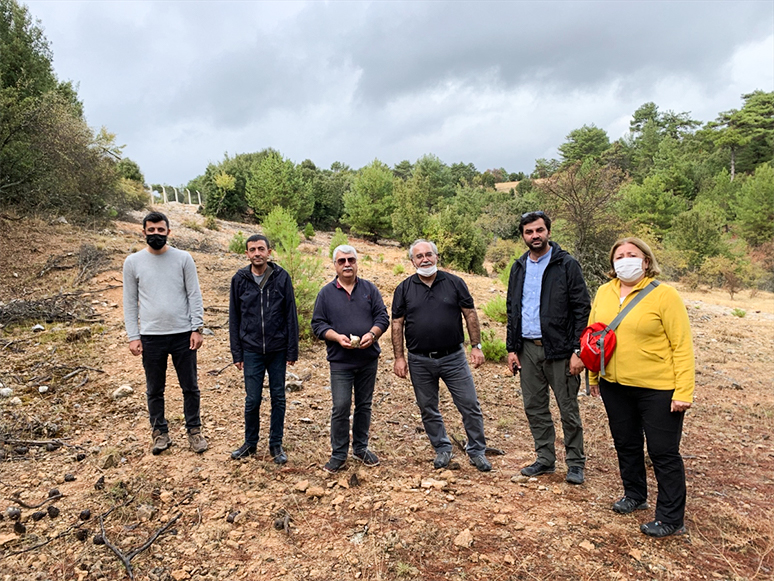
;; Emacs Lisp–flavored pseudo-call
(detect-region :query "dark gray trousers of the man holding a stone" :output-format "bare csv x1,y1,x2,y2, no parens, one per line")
331,359,379,460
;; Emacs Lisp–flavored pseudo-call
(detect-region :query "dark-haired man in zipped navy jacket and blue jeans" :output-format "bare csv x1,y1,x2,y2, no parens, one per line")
228,234,298,464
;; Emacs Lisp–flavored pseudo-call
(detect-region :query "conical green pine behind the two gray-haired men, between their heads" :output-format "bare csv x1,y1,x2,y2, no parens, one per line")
343,159,395,241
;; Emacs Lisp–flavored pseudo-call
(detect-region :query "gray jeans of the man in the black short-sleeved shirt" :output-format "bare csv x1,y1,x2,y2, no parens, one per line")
408,347,486,457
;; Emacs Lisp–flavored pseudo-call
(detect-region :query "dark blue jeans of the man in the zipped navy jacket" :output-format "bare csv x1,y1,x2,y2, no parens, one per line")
244,351,287,448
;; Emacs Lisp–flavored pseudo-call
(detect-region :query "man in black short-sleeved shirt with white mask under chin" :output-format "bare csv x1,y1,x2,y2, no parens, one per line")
392,240,492,472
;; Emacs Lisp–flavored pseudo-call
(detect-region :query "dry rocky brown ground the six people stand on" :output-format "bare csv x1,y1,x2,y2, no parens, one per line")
0,205,774,581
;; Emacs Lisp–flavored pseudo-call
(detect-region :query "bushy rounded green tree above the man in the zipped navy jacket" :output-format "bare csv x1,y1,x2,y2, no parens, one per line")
245,150,314,222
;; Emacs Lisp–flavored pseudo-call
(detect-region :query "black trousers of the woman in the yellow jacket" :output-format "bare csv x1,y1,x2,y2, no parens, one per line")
599,378,686,525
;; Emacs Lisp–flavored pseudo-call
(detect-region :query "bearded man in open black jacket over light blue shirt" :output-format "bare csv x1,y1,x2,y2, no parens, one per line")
506,212,591,484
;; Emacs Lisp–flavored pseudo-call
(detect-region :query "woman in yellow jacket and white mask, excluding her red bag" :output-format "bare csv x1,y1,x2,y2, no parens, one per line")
589,238,694,537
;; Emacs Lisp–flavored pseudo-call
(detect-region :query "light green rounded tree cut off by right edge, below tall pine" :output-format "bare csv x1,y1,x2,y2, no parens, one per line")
736,163,774,245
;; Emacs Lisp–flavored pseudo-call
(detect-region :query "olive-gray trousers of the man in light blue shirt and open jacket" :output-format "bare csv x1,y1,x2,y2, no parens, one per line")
518,340,586,467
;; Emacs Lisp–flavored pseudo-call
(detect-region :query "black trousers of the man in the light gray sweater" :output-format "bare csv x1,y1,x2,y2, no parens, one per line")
140,331,202,433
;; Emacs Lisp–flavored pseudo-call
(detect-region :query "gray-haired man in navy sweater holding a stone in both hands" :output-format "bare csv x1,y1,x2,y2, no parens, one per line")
312,245,390,472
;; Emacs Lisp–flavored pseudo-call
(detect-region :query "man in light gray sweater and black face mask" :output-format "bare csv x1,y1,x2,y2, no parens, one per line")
124,212,207,454
